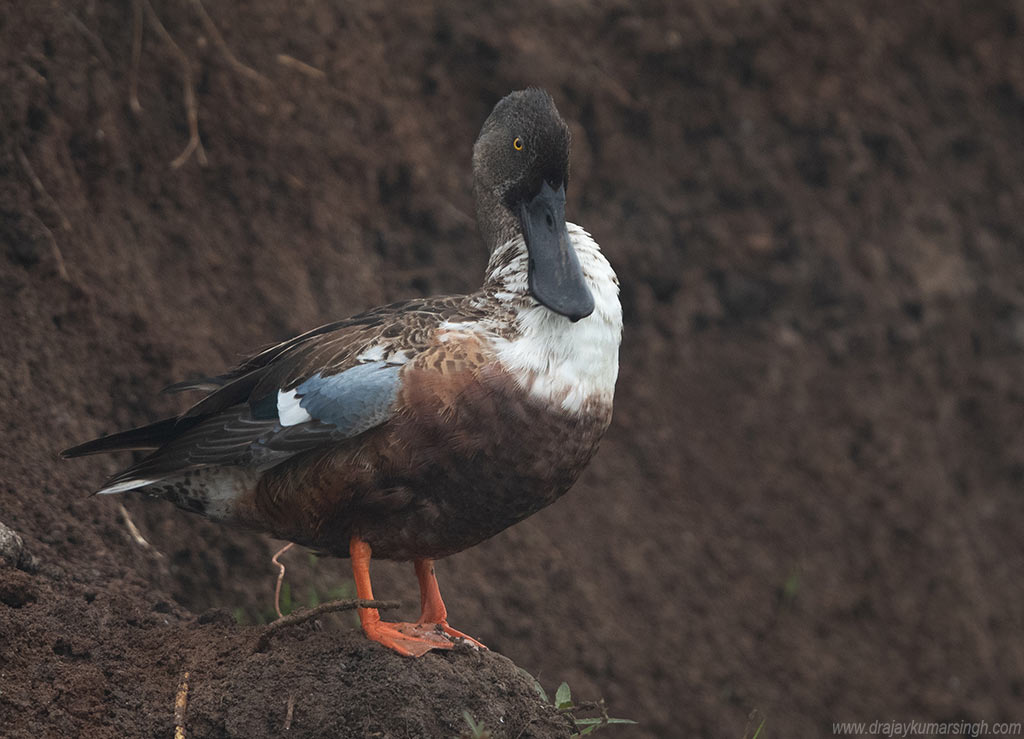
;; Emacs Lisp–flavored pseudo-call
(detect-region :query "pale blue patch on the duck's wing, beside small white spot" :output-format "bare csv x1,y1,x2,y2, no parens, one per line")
295,361,401,437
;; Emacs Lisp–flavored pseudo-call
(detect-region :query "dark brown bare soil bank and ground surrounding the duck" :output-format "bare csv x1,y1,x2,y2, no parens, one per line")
0,0,1024,738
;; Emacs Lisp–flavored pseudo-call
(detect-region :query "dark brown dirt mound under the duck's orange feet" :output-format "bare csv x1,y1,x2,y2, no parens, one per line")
0,556,572,737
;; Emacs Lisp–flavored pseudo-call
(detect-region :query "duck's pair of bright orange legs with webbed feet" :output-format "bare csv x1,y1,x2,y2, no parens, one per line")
348,536,483,657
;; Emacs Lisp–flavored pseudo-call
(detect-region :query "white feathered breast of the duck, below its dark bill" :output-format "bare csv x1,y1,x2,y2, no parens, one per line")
493,223,623,412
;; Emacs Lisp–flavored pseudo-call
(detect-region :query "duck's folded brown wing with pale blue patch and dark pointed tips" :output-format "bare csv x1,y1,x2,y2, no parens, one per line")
62,298,473,492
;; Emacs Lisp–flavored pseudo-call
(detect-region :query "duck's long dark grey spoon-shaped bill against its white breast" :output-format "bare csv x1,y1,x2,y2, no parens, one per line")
519,182,594,322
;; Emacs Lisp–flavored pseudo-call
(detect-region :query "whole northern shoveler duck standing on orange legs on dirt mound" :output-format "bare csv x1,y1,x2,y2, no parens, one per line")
63,89,623,656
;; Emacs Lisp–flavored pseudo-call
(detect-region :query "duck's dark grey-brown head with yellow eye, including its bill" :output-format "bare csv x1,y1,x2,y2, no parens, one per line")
473,88,594,321
